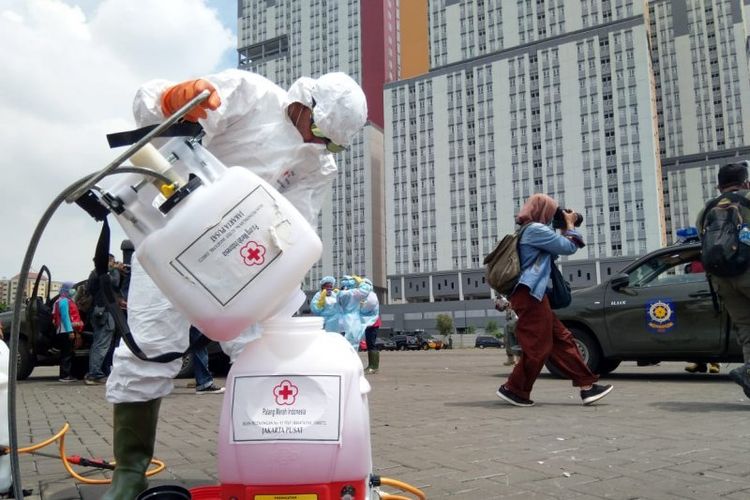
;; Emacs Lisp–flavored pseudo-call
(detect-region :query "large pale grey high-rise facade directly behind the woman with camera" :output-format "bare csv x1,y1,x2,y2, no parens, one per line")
385,1,666,275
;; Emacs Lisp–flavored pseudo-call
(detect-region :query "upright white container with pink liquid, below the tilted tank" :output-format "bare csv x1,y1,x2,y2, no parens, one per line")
218,317,372,485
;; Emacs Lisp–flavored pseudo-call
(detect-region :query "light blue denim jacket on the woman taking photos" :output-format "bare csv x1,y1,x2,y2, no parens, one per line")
514,222,583,302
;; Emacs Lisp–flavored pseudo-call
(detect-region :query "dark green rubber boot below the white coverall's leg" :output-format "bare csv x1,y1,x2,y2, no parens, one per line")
103,398,161,500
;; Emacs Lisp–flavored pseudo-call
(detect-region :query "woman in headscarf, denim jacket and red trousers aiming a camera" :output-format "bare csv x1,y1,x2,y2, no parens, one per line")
497,194,612,406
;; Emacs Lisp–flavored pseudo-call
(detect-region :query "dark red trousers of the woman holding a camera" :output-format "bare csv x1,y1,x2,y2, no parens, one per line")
505,285,599,399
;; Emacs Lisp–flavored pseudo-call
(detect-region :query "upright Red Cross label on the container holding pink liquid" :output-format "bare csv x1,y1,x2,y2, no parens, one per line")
230,375,341,444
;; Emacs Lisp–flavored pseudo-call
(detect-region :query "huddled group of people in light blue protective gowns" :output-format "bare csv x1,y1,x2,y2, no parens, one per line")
310,275,380,374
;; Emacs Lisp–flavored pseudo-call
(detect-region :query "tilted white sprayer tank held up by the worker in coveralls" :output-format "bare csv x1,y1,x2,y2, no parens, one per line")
102,138,322,341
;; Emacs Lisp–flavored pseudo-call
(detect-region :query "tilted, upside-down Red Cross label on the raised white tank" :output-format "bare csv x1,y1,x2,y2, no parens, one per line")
170,186,290,306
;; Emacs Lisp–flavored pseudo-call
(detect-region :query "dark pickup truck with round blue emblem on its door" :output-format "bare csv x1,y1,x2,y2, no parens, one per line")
547,242,742,375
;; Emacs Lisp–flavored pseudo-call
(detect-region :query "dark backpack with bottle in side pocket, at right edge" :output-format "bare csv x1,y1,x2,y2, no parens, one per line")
701,192,750,278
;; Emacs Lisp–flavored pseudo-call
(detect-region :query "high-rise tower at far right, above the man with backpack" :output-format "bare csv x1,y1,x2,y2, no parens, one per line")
647,0,750,237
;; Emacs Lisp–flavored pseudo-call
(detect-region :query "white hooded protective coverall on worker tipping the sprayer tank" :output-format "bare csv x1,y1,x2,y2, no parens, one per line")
107,69,367,403
